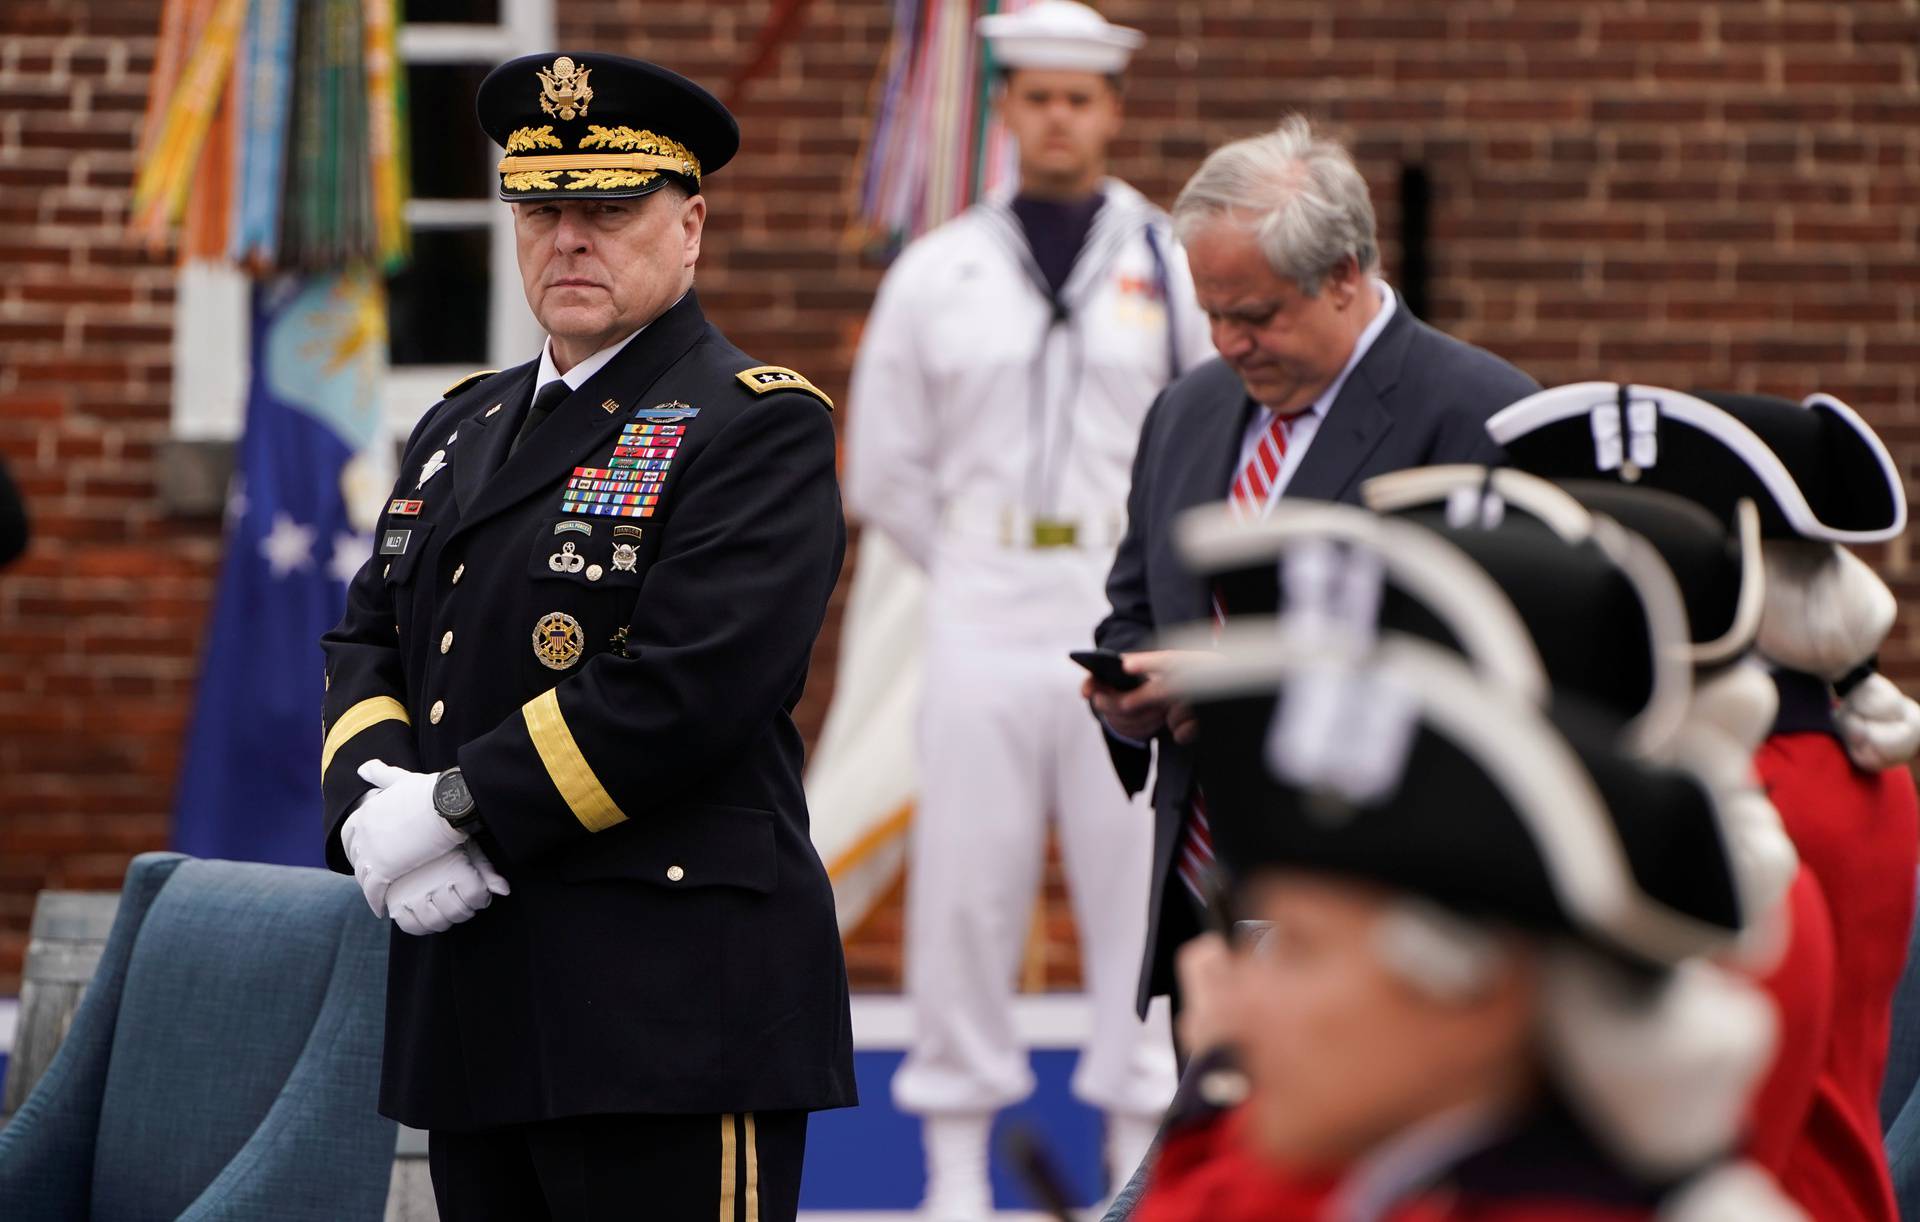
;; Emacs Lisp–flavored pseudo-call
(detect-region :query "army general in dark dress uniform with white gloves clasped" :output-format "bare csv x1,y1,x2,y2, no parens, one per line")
321,52,854,1222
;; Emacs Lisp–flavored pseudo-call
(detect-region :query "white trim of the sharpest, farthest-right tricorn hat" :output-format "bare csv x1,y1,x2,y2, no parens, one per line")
1486,382,1907,544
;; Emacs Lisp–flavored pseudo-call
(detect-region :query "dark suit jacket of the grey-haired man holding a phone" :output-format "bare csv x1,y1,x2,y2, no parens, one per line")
1094,302,1540,1013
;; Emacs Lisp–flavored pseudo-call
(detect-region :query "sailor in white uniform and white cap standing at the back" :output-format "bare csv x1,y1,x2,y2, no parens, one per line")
847,0,1212,1222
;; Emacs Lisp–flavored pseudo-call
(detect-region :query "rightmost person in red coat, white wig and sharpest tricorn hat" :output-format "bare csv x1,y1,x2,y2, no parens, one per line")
1488,382,1920,1222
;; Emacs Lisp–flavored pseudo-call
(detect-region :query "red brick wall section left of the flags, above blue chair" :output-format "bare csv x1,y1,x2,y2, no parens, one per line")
0,0,219,995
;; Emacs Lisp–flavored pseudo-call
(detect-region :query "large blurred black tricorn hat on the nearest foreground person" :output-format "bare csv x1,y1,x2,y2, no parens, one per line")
1175,638,1749,970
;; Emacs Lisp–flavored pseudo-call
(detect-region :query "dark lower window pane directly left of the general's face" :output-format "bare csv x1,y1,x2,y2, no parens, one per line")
386,227,492,369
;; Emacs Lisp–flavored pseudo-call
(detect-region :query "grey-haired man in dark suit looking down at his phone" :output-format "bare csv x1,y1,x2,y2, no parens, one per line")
1085,115,1538,1013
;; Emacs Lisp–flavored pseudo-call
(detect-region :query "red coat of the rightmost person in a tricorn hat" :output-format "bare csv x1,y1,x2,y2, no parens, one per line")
1755,672,1920,1222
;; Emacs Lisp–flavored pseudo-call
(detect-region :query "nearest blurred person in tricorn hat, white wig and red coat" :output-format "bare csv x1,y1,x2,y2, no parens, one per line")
1133,640,1803,1222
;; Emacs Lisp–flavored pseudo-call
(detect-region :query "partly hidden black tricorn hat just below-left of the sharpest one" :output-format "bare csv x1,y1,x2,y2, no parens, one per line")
1361,463,1766,669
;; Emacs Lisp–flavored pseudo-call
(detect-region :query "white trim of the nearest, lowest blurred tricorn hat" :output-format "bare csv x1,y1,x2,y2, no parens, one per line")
1169,636,1745,965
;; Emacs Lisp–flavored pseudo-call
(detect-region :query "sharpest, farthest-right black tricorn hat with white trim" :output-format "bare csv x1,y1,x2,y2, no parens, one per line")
1486,382,1907,544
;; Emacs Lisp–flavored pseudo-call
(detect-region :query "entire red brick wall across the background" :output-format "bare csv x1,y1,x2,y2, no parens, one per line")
0,0,1920,993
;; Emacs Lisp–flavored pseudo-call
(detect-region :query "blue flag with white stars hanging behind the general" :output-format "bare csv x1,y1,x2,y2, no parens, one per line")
173,273,394,865
